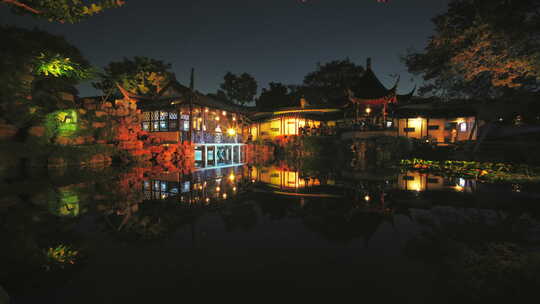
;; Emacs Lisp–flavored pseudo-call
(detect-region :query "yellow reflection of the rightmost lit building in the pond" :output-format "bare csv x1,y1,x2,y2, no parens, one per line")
398,171,476,192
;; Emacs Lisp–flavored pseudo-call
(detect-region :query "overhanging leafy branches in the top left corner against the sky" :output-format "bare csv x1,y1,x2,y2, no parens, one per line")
0,0,125,23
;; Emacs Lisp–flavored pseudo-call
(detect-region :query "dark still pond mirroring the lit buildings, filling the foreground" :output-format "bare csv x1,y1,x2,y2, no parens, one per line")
0,164,540,303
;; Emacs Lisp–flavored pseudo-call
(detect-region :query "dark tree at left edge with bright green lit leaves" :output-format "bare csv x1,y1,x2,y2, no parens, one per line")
0,26,92,126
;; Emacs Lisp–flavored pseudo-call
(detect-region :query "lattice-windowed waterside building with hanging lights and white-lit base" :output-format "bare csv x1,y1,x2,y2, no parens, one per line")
125,77,250,168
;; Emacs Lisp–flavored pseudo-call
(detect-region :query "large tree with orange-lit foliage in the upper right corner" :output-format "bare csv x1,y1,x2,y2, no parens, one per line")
403,0,540,97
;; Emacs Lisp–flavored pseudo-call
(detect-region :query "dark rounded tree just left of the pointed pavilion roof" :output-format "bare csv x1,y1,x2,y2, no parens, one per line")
301,59,364,104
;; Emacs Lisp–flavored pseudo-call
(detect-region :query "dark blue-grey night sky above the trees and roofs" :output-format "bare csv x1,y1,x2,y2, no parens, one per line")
0,0,448,96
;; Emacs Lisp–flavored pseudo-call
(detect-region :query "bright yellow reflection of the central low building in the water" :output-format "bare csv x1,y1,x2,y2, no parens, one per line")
250,167,333,189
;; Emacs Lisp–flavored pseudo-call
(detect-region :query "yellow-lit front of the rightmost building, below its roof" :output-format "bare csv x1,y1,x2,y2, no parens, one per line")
394,105,478,145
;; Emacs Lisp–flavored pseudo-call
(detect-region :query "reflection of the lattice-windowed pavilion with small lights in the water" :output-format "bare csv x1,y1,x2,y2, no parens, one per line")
143,166,248,204
